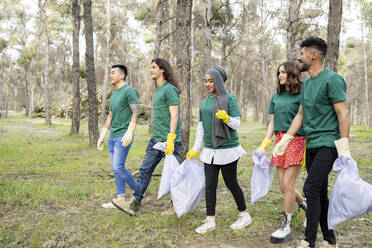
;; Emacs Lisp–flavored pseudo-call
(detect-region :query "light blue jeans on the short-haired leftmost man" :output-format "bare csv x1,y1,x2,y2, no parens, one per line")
108,136,136,196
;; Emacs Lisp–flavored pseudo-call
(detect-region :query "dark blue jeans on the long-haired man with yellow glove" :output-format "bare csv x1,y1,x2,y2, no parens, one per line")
133,138,181,204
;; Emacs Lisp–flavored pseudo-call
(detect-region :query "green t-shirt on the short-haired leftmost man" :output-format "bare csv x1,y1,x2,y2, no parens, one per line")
110,84,138,138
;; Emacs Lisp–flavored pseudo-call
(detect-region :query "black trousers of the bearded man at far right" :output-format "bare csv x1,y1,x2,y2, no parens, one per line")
304,147,338,247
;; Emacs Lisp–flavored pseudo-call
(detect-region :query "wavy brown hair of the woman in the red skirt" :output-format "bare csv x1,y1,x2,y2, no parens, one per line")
276,61,302,95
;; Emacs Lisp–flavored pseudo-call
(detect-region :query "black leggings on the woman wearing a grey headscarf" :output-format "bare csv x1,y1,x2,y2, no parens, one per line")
204,159,247,216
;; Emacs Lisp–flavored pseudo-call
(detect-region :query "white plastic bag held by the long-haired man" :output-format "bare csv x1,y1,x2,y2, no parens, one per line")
152,142,179,200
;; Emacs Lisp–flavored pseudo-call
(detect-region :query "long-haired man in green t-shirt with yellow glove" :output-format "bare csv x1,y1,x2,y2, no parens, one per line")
116,58,181,215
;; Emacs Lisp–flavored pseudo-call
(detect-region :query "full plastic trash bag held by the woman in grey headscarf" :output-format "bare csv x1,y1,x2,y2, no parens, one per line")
171,159,205,217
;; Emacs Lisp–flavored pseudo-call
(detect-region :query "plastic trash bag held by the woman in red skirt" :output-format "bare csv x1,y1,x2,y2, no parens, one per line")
251,151,274,205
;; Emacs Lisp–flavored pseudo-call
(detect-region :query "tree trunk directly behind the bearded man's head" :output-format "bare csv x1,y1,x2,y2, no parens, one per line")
325,0,342,72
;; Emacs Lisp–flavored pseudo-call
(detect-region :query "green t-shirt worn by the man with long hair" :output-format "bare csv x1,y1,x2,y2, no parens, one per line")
153,82,181,142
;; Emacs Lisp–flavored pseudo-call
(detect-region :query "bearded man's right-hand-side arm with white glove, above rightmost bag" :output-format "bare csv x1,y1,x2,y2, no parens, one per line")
333,101,351,158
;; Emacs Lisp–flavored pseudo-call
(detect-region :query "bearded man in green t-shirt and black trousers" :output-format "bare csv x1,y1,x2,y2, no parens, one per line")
273,37,351,248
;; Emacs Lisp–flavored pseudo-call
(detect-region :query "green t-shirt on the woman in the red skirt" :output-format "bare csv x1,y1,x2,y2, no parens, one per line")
267,91,305,136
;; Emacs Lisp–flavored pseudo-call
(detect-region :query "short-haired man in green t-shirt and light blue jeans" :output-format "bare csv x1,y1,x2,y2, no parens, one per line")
97,65,139,208
